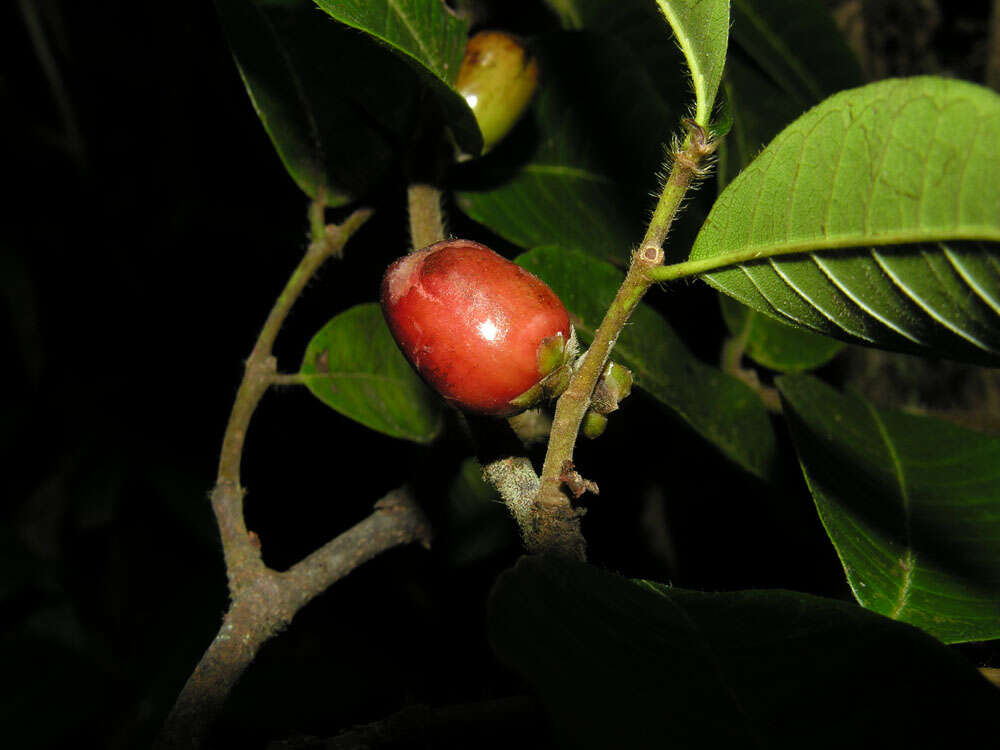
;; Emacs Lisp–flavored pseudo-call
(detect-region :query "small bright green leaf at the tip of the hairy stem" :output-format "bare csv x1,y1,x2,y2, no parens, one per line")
657,0,729,128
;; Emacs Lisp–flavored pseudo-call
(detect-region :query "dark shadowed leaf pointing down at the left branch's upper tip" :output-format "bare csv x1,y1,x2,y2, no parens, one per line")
216,0,417,205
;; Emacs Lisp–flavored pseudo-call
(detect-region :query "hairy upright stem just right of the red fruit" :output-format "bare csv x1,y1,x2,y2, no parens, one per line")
525,120,715,559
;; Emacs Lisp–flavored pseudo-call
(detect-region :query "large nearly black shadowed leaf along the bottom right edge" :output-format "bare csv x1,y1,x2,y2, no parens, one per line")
488,557,1000,750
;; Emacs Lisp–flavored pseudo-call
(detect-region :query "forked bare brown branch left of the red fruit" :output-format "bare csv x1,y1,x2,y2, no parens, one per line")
156,204,430,748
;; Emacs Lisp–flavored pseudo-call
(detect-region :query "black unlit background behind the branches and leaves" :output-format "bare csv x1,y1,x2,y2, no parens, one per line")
0,0,990,748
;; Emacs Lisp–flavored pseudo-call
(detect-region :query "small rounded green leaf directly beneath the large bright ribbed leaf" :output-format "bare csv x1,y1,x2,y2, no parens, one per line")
719,294,844,372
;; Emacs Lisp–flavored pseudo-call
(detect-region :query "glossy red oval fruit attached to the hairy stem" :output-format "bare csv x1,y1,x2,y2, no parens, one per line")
382,240,572,416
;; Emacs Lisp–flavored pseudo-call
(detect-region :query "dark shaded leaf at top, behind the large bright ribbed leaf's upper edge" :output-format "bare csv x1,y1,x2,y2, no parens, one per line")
718,0,863,187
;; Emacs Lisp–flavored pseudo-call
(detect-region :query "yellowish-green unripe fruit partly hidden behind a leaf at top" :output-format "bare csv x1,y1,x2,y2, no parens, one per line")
455,31,538,154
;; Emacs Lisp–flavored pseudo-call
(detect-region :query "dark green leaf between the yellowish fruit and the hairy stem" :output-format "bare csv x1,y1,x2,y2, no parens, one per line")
457,33,684,260
